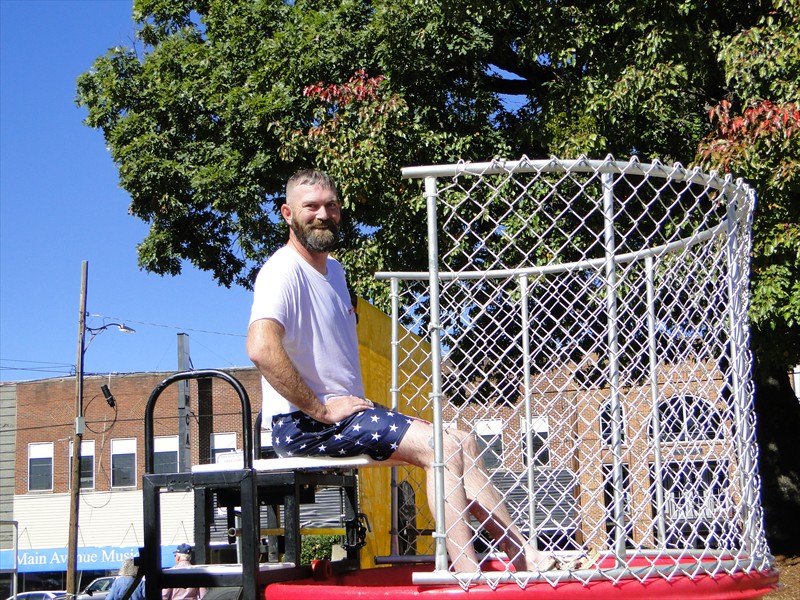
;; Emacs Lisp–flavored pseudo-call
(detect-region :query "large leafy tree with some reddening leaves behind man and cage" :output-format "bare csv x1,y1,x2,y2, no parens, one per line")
77,0,800,540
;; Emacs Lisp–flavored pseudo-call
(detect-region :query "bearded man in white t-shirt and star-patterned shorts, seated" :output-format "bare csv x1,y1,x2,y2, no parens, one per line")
247,171,556,572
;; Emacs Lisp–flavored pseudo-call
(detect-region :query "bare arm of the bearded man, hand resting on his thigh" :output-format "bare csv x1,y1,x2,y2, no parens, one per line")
247,319,372,424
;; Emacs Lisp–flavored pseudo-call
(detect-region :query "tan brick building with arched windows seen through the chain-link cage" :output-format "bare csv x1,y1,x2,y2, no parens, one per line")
443,356,741,548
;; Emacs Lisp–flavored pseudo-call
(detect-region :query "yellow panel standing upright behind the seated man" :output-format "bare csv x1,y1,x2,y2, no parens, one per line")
358,300,432,567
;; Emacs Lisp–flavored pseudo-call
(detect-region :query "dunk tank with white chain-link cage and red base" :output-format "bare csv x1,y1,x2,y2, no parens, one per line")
141,157,778,600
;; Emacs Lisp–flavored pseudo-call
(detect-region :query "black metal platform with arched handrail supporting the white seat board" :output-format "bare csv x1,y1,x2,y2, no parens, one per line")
140,370,368,600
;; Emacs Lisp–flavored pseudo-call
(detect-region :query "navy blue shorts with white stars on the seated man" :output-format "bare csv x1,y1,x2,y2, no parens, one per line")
272,404,414,460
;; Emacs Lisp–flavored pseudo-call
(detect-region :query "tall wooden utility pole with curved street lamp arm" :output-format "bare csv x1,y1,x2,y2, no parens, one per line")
66,261,134,597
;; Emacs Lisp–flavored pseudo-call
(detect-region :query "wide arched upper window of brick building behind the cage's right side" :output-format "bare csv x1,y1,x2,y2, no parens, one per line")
650,396,723,442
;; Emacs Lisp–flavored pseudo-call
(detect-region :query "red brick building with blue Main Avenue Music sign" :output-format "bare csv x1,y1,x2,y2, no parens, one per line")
5,368,261,584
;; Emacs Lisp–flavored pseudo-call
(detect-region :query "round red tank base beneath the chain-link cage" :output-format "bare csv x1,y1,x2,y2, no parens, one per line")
264,561,778,600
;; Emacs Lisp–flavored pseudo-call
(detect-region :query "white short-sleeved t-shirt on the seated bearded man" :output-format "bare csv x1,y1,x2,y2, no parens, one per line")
250,246,364,428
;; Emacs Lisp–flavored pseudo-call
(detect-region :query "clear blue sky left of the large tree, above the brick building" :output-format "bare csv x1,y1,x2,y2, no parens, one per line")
0,0,251,381
